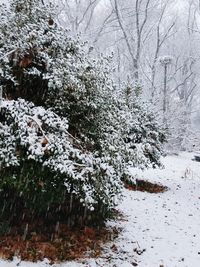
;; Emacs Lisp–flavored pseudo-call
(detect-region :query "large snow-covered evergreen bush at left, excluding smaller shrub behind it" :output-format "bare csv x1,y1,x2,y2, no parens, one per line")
0,0,121,223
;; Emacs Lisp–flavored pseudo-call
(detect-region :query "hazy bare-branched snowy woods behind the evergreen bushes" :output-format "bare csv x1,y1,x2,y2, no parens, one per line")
52,0,200,151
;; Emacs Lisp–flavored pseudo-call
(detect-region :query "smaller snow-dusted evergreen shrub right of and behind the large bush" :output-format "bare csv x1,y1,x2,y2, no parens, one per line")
97,85,166,183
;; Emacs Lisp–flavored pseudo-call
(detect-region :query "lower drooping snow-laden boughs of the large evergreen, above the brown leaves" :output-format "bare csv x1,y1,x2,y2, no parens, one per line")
0,99,120,221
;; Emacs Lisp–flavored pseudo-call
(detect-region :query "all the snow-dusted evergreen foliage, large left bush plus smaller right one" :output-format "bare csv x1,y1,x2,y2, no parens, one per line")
0,0,165,226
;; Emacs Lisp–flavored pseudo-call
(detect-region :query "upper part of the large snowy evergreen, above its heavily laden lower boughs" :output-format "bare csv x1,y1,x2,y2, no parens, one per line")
0,0,110,152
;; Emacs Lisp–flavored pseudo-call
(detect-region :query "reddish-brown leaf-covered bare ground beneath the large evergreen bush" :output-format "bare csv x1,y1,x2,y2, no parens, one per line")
0,224,119,263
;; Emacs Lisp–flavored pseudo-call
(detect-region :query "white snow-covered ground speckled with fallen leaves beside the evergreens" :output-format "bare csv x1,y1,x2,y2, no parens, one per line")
0,153,200,267
